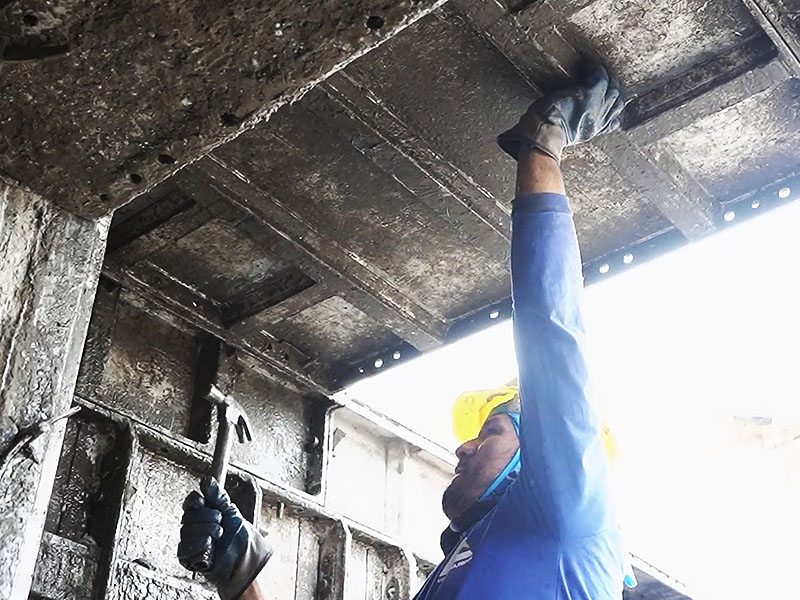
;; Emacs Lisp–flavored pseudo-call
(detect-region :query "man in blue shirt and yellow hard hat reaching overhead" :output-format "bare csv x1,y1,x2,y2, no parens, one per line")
178,68,624,600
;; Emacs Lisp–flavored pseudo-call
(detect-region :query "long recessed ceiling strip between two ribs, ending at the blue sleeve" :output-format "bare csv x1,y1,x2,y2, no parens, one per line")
215,112,506,318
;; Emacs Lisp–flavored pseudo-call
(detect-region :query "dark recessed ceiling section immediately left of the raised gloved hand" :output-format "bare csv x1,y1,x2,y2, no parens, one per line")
344,9,534,204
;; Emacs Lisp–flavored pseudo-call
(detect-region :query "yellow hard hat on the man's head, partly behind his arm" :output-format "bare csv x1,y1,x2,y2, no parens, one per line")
452,385,619,463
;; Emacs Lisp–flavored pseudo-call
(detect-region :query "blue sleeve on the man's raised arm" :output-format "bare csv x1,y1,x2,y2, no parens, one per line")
511,194,610,537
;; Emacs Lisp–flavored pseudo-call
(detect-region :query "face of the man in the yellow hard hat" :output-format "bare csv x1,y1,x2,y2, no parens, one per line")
442,414,519,520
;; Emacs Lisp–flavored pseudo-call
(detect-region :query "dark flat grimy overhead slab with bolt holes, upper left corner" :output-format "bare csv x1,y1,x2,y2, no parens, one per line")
0,0,441,217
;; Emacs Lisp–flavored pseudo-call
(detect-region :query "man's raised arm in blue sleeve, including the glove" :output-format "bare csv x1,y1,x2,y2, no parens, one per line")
498,69,624,537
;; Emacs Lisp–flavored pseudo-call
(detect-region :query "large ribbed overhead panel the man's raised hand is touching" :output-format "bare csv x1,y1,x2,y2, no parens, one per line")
105,0,800,394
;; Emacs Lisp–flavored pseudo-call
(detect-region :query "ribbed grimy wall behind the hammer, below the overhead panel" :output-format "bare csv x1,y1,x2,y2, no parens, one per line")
31,279,452,600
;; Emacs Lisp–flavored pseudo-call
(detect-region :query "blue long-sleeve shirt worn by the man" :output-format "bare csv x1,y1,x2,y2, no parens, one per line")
416,194,623,600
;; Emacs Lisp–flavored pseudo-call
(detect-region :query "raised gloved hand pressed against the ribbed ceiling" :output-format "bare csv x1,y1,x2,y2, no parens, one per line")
497,67,625,162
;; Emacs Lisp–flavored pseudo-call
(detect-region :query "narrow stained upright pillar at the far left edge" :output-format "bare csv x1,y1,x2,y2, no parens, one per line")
0,179,108,600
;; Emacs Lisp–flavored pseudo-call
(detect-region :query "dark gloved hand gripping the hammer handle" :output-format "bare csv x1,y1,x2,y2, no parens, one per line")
178,477,272,600
